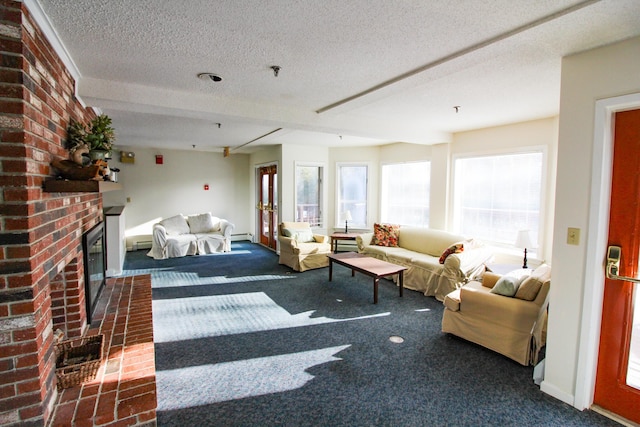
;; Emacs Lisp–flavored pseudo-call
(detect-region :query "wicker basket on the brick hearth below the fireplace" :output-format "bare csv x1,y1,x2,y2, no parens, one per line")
55,334,104,391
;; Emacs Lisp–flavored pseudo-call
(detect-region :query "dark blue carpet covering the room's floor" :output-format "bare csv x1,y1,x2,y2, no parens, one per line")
125,242,617,426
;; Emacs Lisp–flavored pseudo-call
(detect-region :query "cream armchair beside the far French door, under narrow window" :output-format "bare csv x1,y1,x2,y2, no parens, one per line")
278,221,331,271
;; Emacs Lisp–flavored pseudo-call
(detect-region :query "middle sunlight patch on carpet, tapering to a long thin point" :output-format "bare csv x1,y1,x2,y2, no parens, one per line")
153,292,390,343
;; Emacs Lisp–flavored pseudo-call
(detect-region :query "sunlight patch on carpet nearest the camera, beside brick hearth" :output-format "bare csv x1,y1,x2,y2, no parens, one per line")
156,345,350,411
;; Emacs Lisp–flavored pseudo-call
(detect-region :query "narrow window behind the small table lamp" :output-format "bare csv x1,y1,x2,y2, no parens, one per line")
336,164,368,231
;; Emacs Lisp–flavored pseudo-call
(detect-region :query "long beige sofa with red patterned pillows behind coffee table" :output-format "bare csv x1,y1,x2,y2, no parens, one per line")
356,227,493,301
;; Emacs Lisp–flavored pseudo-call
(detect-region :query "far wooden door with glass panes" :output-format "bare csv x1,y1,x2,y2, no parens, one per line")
257,165,278,249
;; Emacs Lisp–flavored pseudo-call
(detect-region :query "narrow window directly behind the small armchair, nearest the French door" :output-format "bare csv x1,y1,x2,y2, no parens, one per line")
295,165,324,227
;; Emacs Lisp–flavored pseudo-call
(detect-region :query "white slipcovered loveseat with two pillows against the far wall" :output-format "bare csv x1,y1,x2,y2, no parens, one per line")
147,212,235,259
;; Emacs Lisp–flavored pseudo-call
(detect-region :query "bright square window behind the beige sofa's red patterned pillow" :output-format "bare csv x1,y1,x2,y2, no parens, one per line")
380,162,431,227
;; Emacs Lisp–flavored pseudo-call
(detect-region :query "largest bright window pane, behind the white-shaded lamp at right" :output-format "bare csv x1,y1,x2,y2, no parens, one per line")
454,151,544,247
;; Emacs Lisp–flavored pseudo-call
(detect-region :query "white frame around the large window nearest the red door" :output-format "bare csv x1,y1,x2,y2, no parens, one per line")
449,145,549,251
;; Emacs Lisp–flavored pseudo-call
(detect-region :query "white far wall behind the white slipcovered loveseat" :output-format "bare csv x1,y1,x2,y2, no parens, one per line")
103,146,252,249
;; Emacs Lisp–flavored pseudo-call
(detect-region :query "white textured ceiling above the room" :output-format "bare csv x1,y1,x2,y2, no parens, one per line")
33,0,640,153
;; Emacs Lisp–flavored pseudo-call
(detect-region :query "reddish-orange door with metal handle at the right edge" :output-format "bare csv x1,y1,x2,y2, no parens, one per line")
594,110,640,423
